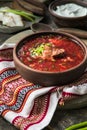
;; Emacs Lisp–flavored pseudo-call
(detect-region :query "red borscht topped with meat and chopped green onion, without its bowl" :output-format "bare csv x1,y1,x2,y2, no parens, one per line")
18,34,84,72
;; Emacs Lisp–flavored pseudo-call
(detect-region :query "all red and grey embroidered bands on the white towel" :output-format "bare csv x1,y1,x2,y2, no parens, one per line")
0,48,50,130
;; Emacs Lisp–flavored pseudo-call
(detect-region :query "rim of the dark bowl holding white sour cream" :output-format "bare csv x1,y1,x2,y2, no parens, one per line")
48,0,87,20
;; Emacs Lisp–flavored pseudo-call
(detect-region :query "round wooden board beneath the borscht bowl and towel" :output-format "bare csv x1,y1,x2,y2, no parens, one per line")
3,30,87,109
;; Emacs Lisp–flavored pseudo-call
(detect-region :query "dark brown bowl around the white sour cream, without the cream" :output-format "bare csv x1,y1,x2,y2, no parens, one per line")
49,0,87,29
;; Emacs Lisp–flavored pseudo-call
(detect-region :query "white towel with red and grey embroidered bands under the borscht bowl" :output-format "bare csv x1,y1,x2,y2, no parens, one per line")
0,44,87,130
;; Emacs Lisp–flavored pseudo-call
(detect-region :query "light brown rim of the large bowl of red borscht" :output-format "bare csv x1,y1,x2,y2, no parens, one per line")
13,31,87,74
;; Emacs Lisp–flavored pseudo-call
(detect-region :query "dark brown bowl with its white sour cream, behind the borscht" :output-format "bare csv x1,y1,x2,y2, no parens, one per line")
49,0,87,29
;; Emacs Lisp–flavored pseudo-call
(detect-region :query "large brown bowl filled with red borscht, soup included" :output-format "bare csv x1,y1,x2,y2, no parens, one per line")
13,31,87,87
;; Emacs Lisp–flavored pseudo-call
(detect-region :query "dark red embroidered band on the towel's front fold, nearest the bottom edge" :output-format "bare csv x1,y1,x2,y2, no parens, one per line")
13,95,49,130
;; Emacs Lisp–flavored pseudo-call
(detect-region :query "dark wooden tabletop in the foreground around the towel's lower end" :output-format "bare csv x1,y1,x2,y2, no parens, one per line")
0,107,87,130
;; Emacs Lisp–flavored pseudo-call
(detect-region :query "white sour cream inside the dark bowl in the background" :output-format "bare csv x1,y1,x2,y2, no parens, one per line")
54,3,87,17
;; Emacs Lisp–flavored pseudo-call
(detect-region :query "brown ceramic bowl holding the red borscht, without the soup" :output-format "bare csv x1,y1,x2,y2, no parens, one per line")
13,31,87,86
